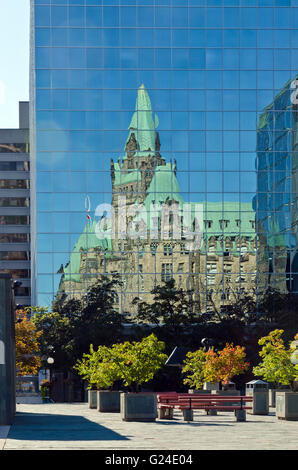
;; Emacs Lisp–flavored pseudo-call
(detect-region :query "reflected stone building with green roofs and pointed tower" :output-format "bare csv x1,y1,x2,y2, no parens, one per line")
58,86,256,312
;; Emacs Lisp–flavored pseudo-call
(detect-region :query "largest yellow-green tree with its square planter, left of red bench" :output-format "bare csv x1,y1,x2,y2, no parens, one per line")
112,334,167,421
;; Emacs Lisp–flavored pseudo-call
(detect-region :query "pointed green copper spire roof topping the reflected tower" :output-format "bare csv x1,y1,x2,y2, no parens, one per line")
126,85,158,157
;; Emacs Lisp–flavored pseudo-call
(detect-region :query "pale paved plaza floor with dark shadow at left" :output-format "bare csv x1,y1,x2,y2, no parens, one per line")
0,403,298,451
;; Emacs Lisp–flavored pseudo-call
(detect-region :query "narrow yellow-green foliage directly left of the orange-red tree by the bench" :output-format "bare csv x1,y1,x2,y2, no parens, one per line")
182,348,207,390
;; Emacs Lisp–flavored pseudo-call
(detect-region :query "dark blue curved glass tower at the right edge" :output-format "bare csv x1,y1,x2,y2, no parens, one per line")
254,82,298,293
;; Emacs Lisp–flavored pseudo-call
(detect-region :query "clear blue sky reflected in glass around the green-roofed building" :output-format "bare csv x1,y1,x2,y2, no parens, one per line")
35,0,298,303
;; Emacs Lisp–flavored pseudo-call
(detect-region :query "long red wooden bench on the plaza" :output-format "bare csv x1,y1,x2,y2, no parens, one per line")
157,393,253,421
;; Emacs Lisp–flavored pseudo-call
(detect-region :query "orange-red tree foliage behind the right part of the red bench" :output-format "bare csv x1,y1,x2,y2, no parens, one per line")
205,344,249,385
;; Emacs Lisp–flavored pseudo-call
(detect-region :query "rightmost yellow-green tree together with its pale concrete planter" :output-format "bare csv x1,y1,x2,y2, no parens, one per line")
253,329,298,420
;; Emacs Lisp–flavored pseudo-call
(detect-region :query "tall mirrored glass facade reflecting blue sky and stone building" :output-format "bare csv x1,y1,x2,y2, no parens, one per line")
30,0,298,313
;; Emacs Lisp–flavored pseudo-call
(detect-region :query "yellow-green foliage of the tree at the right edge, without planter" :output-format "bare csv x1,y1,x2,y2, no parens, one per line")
253,329,298,388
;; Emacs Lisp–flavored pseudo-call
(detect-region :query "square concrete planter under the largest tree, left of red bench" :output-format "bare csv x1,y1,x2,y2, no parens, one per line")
120,392,157,421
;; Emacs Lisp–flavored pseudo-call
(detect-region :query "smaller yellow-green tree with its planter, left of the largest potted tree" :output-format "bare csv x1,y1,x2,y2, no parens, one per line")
74,344,120,412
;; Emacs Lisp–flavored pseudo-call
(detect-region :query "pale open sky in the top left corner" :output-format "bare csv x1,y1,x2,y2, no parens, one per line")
0,0,30,128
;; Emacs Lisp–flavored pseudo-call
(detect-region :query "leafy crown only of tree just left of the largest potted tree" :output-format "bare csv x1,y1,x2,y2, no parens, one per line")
74,344,120,390
